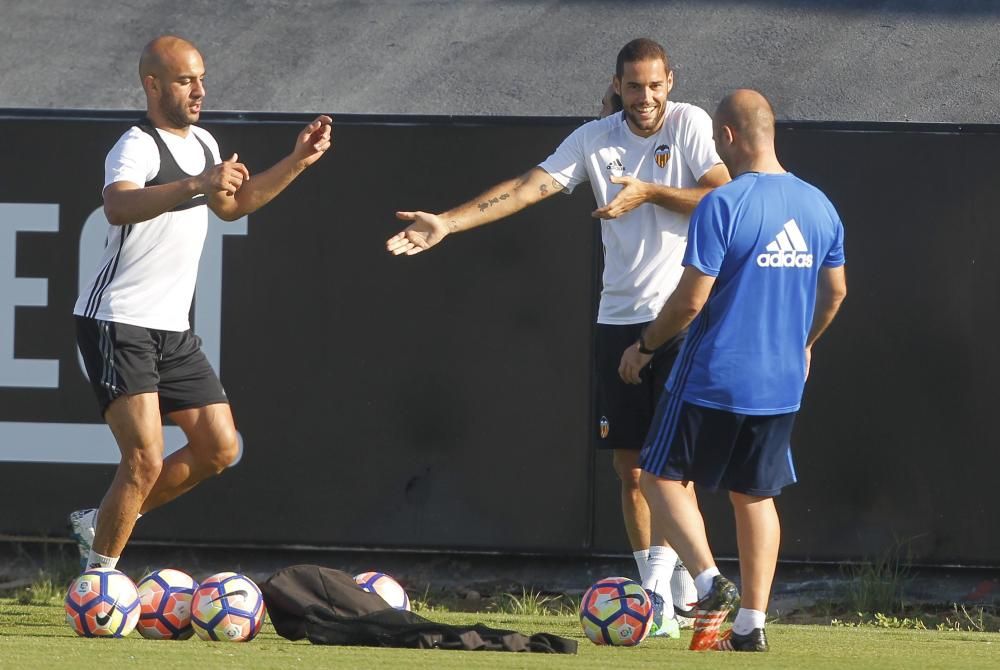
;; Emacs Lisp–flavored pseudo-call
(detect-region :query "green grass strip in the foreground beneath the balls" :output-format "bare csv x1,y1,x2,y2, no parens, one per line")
0,599,1000,670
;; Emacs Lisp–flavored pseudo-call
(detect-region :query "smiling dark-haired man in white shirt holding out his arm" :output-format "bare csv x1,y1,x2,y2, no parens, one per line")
386,38,729,637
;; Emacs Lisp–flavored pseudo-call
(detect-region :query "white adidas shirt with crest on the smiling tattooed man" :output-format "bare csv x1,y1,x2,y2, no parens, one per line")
539,101,722,324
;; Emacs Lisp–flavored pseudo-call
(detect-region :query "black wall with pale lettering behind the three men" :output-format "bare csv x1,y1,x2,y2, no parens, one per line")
0,112,1000,565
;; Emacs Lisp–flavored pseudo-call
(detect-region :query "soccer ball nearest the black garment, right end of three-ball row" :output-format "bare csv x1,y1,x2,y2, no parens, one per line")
191,572,264,642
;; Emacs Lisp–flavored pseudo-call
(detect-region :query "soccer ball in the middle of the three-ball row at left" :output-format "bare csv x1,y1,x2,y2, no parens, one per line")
137,568,198,640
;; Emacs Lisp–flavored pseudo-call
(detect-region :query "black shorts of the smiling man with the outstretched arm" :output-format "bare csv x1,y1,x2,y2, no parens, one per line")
594,323,684,450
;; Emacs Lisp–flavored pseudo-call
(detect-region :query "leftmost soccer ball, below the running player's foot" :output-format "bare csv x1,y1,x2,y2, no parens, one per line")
66,568,139,637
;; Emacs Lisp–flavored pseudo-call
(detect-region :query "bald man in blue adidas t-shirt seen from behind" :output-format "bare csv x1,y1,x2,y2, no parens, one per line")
619,89,847,651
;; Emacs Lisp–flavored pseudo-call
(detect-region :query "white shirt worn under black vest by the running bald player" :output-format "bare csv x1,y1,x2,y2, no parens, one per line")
73,126,222,332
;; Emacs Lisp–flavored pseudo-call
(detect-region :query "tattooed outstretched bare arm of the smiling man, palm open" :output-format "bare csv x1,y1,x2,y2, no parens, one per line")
385,167,563,256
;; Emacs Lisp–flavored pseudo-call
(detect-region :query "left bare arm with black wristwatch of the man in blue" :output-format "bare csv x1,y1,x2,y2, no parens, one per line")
618,265,715,384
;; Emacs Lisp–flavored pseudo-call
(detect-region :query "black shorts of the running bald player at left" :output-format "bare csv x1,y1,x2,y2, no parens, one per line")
76,316,229,416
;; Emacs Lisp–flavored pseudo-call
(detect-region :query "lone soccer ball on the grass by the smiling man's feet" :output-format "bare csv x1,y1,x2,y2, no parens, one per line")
580,577,653,647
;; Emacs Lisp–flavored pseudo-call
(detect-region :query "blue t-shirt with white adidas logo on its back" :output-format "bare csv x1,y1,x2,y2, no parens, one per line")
667,172,844,414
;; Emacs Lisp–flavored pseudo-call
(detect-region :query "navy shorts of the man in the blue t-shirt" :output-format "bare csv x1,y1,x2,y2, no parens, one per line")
639,391,798,497
